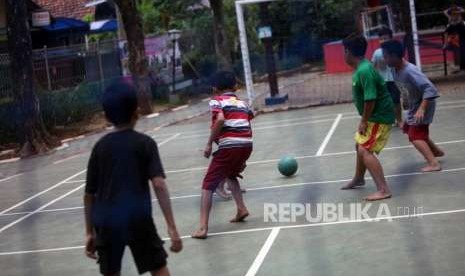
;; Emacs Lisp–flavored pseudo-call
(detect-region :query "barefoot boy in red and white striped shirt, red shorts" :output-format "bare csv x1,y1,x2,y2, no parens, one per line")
192,71,253,239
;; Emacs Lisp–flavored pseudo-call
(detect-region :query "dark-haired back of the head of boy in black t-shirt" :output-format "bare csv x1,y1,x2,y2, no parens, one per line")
102,80,137,126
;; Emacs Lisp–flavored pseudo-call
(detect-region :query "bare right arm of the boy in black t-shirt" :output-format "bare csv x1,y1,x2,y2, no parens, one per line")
151,177,182,252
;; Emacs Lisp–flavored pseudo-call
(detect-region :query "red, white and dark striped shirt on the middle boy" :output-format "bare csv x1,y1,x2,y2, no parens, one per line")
210,93,253,149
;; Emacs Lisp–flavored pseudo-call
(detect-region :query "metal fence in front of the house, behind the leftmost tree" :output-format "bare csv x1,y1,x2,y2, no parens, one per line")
0,40,122,99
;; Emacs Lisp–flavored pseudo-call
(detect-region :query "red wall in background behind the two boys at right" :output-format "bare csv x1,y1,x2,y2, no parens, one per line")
323,35,453,74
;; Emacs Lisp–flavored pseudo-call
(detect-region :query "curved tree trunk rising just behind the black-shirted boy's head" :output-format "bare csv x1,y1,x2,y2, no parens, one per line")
115,0,152,115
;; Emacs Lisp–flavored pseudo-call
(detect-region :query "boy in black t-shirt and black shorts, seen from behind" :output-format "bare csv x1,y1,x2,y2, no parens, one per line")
84,81,182,275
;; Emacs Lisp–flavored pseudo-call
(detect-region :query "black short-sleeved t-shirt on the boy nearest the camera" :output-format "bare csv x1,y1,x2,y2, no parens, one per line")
85,130,165,227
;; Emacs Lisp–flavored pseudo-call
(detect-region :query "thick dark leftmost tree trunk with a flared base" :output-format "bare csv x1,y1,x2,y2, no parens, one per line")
6,0,59,157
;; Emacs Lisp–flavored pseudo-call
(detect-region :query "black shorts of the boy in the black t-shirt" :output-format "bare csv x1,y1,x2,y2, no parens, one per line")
97,221,168,275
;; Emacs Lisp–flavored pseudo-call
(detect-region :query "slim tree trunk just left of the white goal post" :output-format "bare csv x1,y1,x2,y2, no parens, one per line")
210,0,232,70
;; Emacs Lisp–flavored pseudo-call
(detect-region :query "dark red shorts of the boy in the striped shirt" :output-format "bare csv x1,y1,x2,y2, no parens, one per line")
202,147,252,191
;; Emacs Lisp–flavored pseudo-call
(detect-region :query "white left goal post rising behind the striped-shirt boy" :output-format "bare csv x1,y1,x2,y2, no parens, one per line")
236,0,281,106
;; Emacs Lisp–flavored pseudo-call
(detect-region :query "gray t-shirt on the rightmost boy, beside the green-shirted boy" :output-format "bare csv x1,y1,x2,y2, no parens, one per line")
393,63,439,125
